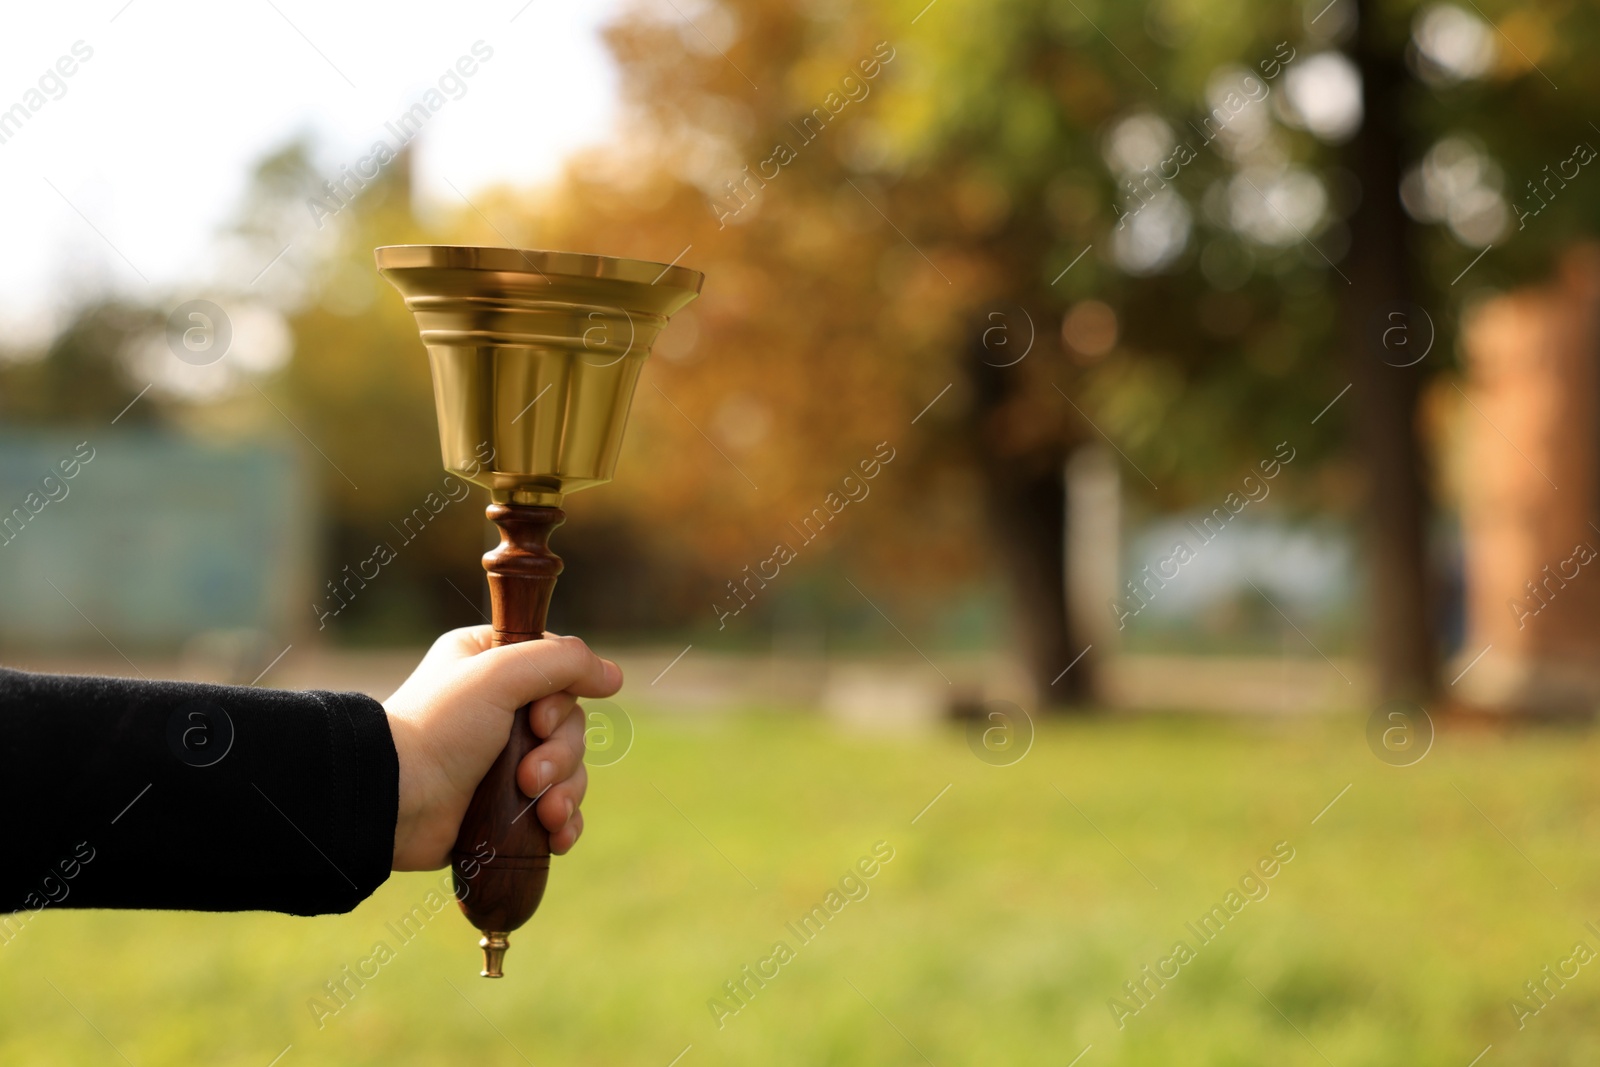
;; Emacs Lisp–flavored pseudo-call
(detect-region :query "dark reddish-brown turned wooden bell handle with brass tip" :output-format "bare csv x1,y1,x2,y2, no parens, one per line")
451,504,566,977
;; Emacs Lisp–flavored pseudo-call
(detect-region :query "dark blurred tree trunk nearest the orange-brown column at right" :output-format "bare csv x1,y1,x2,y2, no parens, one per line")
1344,0,1438,701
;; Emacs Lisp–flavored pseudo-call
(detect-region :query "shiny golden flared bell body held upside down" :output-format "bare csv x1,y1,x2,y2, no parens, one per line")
378,245,704,507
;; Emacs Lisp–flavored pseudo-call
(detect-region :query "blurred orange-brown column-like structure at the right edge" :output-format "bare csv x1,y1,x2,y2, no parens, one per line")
1446,248,1600,713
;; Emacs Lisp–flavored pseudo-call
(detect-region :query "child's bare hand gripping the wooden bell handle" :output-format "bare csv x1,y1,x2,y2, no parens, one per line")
384,625,622,870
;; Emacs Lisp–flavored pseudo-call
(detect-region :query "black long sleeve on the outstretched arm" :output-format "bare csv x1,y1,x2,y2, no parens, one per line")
0,670,400,923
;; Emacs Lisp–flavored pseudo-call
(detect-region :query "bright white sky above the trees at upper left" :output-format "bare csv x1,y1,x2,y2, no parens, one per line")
0,0,619,343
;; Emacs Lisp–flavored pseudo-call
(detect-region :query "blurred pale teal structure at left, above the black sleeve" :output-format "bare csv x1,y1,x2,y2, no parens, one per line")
0,429,314,668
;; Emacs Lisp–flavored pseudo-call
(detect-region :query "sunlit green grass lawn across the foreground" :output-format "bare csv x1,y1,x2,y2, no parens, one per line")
0,715,1600,1067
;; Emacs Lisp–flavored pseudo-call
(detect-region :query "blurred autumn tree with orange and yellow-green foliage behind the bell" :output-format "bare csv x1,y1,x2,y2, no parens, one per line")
464,0,1338,704
